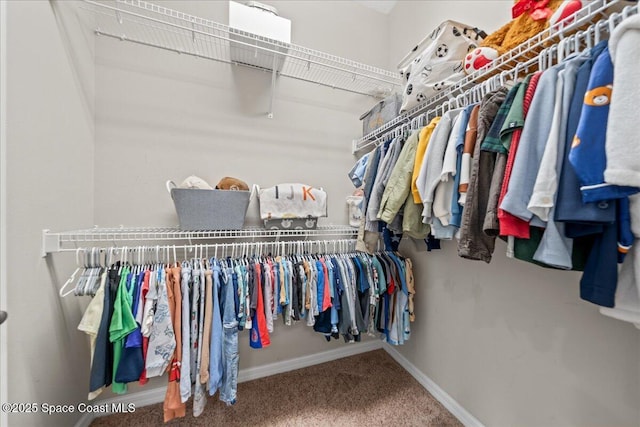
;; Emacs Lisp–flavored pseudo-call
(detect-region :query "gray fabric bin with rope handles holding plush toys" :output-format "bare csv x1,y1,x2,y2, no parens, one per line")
171,188,251,230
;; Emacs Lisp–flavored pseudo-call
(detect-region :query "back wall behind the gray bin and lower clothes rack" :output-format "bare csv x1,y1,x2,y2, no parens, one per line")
94,1,389,402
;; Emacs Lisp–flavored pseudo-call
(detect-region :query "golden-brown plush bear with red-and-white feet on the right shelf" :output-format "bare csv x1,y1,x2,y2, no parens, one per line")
464,0,583,74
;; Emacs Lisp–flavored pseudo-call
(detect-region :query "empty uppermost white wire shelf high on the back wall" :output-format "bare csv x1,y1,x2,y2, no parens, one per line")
83,0,401,97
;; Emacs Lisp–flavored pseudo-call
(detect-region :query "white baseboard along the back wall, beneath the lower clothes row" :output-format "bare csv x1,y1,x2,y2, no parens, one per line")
75,340,383,427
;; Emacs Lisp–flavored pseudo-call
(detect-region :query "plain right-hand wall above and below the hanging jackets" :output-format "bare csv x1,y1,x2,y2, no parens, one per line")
390,1,640,427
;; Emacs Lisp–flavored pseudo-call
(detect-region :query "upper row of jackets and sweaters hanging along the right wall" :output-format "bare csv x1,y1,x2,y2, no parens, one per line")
350,6,640,327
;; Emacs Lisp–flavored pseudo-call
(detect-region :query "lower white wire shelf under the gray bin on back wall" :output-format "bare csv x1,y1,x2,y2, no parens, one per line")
42,225,358,256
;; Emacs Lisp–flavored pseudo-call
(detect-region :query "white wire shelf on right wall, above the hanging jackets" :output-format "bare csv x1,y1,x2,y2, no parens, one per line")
352,0,636,153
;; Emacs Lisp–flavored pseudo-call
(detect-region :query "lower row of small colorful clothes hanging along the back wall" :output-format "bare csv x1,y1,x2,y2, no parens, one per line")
75,240,415,421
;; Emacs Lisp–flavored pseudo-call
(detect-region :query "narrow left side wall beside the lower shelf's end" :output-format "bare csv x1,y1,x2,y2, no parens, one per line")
2,1,94,426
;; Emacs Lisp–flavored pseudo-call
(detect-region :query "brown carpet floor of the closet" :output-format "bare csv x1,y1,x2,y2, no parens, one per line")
91,350,462,427
